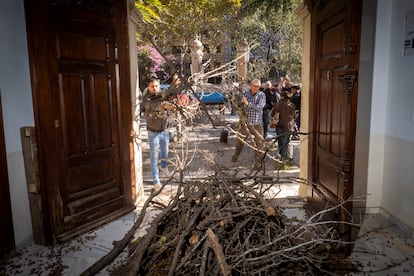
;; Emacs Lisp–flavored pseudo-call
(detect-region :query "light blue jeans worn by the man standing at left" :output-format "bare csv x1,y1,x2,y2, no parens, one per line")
148,130,170,184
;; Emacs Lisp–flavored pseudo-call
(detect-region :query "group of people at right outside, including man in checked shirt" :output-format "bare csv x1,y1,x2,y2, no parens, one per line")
232,77,301,164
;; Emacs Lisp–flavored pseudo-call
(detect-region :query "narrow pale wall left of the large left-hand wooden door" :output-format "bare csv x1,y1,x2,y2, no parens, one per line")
0,0,34,247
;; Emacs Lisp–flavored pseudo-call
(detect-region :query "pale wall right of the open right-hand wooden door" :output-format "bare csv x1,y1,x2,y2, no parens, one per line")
367,0,414,231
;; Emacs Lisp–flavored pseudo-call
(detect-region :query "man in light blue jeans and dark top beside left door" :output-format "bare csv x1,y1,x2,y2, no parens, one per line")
142,79,174,191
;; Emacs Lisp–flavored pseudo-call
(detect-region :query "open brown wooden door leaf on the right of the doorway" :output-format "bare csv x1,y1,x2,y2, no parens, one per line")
309,0,361,238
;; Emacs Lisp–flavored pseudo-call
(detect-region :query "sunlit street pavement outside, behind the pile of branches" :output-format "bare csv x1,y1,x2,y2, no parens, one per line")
141,107,299,188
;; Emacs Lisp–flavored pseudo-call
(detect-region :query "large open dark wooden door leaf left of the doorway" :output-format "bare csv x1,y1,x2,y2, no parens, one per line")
26,0,133,241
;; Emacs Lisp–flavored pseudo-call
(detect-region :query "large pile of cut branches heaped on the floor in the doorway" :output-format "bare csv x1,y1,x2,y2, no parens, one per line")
103,171,356,275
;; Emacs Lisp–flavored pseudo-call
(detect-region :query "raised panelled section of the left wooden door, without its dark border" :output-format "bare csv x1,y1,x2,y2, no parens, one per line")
51,23,128,237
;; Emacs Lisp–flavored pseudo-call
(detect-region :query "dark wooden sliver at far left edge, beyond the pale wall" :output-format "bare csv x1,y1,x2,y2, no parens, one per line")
0,94,14,259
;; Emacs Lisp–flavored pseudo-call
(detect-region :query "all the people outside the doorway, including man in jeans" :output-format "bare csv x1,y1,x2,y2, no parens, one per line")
141,75,301,190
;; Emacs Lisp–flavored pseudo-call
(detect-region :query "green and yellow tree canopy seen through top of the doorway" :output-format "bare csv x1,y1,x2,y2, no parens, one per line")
135,0,302,84
